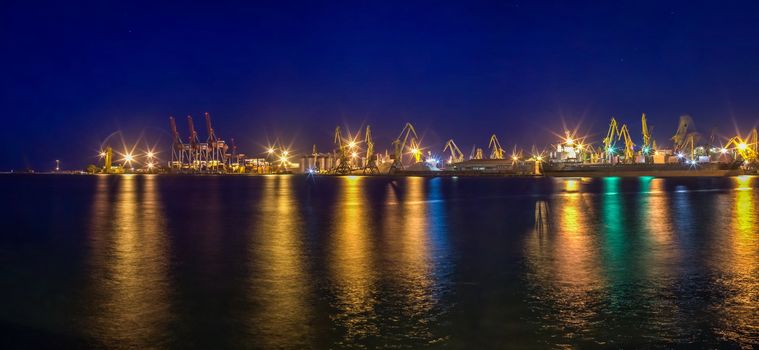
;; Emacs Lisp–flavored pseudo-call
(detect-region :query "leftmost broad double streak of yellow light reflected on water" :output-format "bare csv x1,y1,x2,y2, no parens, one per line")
84,175,171,348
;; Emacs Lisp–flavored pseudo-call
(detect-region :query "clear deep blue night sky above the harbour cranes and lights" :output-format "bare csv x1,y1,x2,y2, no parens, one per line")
0,1,759,170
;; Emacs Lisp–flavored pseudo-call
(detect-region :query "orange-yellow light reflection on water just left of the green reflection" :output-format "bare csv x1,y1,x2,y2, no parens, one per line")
526,189,604,334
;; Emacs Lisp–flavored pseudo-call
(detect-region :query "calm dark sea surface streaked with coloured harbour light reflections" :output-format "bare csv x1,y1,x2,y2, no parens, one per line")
0,175,759,349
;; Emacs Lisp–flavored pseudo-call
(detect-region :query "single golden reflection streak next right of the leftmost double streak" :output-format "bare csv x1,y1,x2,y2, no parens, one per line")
250,176,312,348
